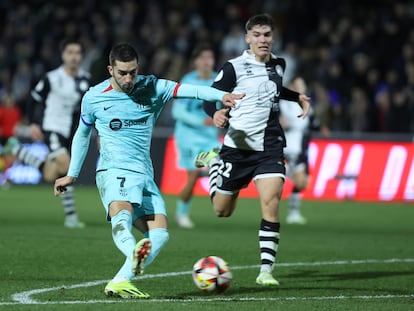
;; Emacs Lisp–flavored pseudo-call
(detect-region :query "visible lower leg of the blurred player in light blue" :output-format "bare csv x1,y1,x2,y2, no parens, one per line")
175,170,199,229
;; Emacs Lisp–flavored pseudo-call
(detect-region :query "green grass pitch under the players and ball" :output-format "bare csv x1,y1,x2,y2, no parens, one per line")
0,186,414,310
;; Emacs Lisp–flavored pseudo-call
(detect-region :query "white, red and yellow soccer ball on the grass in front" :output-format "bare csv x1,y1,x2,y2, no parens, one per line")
193,256,233,293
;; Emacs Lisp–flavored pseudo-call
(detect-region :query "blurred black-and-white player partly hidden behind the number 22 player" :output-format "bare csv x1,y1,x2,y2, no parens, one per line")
279,77,328,224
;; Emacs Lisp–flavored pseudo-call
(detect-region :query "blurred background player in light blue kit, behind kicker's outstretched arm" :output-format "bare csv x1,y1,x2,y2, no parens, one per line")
172,44,220,228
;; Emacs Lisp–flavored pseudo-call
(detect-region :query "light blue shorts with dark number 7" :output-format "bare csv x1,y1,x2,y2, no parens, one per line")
96,169,167,222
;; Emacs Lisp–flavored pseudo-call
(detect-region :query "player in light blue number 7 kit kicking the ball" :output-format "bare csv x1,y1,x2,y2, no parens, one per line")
54,43,244,298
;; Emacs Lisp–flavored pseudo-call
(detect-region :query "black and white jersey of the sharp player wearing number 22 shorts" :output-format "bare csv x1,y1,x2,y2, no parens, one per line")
213,51,299,151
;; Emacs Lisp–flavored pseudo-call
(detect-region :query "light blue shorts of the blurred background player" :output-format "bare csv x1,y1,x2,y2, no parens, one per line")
176,139,220,171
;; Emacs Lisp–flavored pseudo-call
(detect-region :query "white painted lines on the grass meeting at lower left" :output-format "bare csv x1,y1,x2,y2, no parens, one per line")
6,258,414,305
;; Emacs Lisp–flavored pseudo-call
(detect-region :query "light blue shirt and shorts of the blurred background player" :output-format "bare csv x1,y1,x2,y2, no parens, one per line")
172,71,220,170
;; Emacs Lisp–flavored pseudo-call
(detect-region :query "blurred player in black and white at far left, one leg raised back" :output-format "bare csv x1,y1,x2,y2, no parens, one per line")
3,39,90,228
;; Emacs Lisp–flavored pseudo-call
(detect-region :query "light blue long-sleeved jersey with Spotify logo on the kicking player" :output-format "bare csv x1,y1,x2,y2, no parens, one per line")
68,75,226,177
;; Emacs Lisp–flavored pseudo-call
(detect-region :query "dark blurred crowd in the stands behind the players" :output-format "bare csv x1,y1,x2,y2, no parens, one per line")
0,0,414,141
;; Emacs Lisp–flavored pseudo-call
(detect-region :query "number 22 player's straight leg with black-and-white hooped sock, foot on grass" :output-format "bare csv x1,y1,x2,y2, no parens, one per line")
255,177,284,286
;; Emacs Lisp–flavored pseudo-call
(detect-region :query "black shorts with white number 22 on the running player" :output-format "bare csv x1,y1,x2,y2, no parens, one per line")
217,146,286,194
